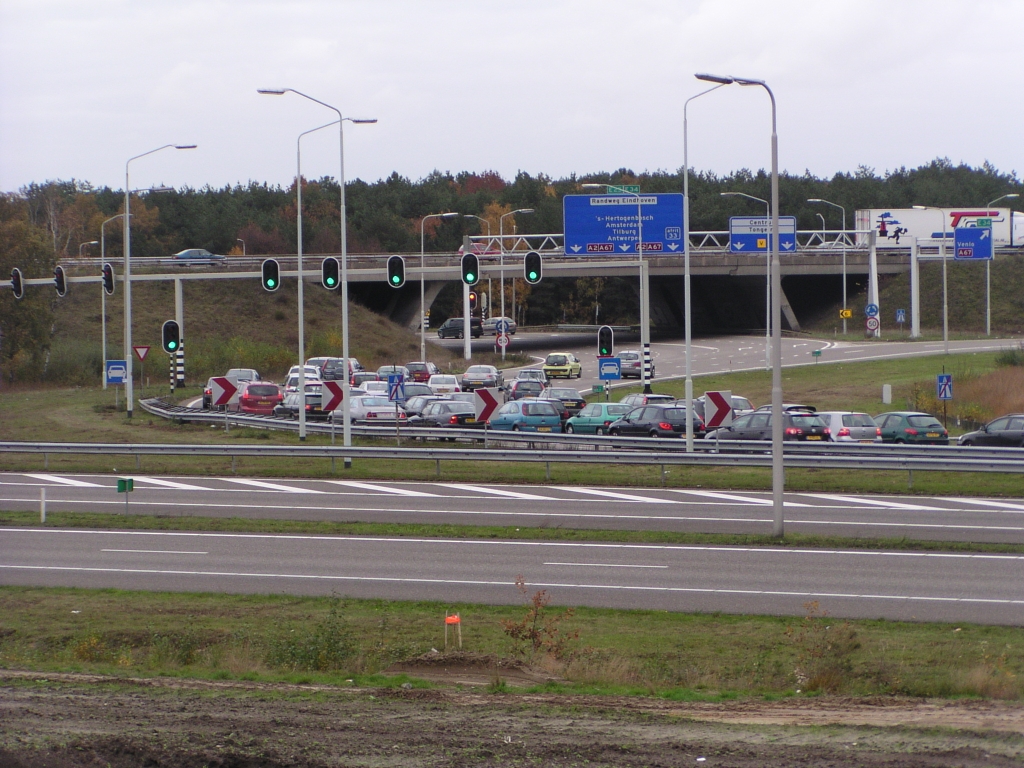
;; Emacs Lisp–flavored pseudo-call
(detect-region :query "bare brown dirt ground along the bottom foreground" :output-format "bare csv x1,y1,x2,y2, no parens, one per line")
0,658,1024,768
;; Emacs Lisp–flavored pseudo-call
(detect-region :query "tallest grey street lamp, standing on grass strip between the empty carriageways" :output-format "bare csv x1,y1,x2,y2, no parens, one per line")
696,75,785,537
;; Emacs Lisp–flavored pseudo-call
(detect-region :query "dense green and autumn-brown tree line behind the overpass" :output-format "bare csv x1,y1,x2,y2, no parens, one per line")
0,159,1024,382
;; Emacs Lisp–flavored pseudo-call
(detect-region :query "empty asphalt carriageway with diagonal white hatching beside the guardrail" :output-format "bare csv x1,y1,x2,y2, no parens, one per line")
0,469,1024,544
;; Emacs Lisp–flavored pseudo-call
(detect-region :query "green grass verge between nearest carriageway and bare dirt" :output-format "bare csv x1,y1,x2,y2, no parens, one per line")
0,577,1024,700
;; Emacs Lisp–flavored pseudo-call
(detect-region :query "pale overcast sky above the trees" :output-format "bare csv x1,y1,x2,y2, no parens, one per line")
0,0,1024,191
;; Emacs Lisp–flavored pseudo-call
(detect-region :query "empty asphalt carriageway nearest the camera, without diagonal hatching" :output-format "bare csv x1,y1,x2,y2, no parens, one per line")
0,528,1024,625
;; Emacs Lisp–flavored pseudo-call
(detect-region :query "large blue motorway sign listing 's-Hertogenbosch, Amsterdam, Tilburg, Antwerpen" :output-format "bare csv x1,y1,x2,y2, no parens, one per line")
562,193,683,256
